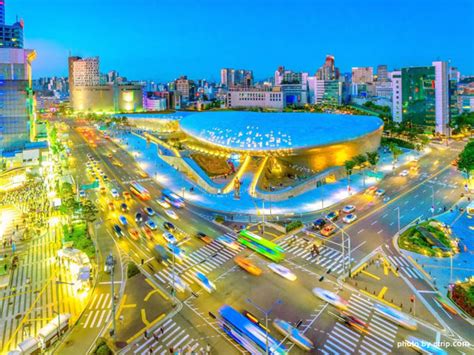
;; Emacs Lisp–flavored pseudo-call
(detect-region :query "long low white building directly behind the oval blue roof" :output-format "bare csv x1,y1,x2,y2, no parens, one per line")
226,89,284,110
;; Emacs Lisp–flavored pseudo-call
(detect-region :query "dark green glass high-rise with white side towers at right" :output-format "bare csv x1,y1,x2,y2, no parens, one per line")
392,61,451,135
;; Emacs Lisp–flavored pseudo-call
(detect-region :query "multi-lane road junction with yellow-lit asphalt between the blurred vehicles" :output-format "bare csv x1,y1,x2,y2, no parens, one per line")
56,120,469,354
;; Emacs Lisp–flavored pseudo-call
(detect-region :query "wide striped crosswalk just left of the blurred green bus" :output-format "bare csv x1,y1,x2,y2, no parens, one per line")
155,233,243,285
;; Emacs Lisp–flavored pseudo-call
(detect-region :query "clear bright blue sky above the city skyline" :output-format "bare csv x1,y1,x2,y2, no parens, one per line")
10,0,474,81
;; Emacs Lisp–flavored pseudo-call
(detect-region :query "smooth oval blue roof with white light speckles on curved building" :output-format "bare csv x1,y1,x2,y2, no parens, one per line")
180,111,383,150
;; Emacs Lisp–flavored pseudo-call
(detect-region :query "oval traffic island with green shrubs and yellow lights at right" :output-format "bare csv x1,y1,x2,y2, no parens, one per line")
398,220,458,257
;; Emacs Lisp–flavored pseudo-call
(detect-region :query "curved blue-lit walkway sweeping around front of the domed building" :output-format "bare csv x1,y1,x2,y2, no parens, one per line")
110,129,418,216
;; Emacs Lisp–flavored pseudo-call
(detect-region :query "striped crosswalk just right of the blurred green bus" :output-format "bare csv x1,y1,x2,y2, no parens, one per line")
278,238,354,274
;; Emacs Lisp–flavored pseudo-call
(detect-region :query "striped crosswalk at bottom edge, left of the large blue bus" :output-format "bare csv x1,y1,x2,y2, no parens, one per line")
133,318,205,354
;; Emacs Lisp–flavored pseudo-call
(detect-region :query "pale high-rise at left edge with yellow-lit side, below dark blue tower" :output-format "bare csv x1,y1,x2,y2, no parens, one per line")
0,48,36,156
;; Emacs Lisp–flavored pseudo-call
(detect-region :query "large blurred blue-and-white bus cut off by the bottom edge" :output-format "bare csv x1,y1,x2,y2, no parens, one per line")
219,305,287,355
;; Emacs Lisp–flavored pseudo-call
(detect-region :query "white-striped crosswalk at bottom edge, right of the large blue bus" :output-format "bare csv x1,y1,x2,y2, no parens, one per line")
321,294,398,355
